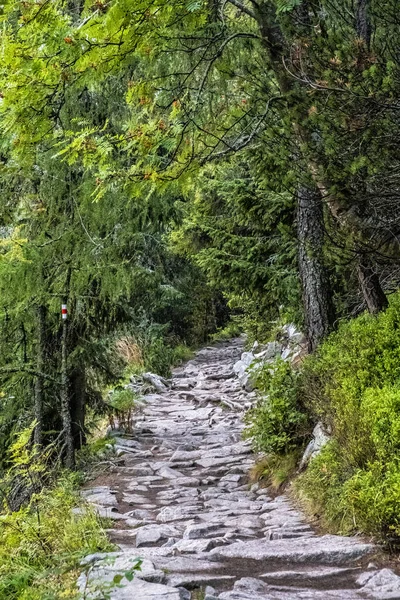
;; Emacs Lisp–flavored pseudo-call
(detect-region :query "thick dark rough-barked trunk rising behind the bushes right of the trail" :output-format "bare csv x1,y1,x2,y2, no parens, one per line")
297,186,334,352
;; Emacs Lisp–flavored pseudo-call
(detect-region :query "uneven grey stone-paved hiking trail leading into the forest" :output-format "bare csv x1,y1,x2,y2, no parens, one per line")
79,338,400,600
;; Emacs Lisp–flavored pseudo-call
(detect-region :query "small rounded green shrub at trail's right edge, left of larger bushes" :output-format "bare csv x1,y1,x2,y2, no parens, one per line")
245,360,310,455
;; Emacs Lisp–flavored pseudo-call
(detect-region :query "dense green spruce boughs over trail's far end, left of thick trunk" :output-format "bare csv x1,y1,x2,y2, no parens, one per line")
171,157,301,340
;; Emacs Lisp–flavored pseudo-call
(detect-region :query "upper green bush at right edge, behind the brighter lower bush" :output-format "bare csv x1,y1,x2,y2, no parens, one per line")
302,294,400,466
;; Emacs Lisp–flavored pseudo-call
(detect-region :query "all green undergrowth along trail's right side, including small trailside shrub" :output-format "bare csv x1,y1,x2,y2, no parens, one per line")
247,293,400,547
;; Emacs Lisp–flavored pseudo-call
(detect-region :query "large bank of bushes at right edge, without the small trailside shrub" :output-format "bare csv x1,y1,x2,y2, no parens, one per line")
297,294,400,541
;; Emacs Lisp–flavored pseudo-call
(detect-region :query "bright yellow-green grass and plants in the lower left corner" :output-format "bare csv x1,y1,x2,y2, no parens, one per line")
0,431,111,600
